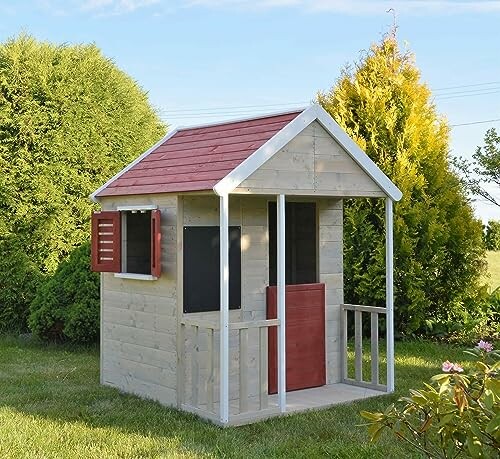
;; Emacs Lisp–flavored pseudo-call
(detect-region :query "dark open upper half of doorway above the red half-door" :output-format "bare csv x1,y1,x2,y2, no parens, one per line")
268,202,317,285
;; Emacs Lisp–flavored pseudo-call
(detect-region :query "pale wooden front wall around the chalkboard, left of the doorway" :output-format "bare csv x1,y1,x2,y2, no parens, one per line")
179,195,269,403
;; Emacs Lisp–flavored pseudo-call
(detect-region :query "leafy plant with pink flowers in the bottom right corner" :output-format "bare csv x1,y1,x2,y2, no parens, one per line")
361,340,500,459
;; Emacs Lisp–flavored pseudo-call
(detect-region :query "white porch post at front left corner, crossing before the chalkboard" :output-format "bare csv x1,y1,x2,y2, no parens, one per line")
219,194,229,424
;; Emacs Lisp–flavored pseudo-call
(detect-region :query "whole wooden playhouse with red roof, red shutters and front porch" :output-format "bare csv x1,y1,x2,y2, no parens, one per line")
92,105,401,425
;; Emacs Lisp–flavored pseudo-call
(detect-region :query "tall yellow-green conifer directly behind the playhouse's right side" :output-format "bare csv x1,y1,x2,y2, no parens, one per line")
318,34,484,333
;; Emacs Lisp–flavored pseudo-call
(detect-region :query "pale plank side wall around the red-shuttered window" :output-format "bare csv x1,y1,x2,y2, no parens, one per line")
101,195,177,406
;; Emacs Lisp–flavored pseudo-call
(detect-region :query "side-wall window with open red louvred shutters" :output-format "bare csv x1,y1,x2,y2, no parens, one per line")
92,206,161,278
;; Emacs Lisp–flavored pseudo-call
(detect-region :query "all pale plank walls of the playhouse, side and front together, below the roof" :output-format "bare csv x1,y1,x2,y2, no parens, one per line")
101,194,343,412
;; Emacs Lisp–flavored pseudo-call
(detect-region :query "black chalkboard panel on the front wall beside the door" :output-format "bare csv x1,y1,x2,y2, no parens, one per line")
183,226,241,312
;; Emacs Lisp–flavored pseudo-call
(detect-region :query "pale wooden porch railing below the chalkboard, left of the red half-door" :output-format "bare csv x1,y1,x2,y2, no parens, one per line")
177,317,279,425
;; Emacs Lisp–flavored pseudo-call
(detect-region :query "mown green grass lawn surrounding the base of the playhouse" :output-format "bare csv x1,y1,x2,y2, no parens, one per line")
0,337,472,459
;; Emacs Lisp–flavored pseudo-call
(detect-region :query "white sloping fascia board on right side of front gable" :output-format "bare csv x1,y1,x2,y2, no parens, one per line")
313,104,403,201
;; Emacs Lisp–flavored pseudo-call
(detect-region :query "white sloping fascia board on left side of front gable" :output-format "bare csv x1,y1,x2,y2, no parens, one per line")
214,105,316,196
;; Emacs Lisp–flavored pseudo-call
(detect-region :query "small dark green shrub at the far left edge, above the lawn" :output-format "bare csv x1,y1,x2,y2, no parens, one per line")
0,238,43,333
